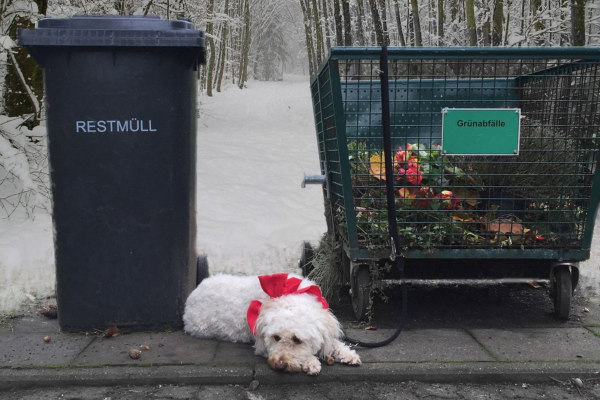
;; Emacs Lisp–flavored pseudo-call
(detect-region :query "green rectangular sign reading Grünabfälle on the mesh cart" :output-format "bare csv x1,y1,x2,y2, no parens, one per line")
442,108,521,156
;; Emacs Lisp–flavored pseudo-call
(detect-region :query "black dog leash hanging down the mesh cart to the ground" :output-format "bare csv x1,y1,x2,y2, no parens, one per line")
344,46,408,348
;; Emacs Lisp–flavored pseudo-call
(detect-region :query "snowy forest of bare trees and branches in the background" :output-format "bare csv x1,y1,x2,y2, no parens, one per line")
0,0,600,218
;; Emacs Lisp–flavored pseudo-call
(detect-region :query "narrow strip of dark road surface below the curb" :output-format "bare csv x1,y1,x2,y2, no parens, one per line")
0,381,600,400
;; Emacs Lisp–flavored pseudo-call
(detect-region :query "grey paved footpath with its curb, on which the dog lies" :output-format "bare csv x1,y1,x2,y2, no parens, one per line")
0,313,600,390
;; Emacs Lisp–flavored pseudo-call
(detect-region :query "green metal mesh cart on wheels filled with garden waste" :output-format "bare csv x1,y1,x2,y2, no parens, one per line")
303,47,600,319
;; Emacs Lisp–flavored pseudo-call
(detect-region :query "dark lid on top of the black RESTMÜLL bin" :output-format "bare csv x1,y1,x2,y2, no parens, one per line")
19,15,204,48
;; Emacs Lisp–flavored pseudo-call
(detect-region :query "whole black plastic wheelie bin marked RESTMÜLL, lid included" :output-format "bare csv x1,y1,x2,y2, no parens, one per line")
19,16,204,332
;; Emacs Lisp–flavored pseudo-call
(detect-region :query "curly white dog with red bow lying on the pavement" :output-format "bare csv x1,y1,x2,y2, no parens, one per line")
183,274,360,375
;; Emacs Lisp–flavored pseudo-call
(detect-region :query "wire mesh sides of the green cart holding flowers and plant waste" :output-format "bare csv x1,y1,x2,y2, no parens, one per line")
313,49,600,260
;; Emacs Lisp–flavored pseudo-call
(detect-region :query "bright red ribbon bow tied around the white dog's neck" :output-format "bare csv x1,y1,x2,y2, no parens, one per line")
246,273,329,335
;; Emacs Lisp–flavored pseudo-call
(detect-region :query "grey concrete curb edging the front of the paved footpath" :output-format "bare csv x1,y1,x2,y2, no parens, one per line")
0,362,600,390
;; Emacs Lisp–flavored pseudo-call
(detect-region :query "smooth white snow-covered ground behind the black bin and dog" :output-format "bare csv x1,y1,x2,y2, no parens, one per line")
0,76,326,313
